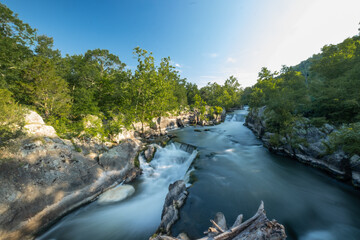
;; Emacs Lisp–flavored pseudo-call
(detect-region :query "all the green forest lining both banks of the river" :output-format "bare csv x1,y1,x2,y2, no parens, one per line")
0,4,360,157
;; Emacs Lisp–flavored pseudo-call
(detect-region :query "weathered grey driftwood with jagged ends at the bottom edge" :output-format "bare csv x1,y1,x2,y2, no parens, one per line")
150,202,286,240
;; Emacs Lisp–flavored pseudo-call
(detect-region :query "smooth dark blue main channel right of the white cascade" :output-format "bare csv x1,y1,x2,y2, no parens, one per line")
173,110,360,240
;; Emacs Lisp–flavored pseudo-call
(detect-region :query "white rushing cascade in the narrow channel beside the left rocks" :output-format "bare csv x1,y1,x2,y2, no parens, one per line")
38,143,197,240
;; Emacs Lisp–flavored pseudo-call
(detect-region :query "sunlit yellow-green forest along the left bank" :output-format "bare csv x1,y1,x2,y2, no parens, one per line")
0,4,242,141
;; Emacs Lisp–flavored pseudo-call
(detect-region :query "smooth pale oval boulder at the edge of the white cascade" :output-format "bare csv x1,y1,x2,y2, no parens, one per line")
98,184,135,204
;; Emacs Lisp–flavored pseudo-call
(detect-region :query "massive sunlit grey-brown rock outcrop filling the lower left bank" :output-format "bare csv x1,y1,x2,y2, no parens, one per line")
0,113,141,240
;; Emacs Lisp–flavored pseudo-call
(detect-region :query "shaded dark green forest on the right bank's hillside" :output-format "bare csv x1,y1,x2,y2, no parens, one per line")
242,31,360,154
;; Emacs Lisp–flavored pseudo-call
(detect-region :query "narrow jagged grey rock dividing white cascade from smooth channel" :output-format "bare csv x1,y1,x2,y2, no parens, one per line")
157,180,188,234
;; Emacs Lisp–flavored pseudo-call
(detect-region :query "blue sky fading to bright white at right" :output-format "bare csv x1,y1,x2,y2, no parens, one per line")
1,0,360,87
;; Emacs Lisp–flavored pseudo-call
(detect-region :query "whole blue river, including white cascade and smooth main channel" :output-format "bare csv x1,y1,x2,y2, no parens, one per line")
38,110,360,240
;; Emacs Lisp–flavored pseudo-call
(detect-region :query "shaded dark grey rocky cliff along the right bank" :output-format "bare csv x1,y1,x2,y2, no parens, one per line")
245,107,360,187
